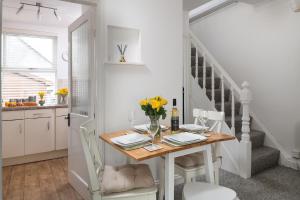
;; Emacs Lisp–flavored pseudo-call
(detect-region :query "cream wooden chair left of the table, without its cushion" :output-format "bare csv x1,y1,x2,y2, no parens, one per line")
80,120,157,200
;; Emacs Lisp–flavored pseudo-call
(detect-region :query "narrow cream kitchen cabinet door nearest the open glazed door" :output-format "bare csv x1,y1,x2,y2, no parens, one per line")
55,115,69,150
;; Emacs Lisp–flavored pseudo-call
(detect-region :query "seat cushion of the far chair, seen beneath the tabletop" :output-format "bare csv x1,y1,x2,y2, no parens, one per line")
175,152,217,168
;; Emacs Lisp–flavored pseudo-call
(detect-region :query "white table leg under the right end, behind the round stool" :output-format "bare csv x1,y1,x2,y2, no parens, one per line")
203,145,215,184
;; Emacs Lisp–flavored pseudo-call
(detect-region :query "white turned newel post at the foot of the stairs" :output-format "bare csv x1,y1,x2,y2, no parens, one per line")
239,82,252,178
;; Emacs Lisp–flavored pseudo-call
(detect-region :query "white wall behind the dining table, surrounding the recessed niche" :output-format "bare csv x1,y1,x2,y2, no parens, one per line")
104,0,183,178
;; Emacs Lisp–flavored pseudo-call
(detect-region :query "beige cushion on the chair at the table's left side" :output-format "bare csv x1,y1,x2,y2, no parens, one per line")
101,164,154,194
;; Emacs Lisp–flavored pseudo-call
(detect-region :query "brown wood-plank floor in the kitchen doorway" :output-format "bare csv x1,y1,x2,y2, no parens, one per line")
3,158,82,200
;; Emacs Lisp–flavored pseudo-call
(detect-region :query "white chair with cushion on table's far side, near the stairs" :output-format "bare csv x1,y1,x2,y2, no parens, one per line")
175,109,225,184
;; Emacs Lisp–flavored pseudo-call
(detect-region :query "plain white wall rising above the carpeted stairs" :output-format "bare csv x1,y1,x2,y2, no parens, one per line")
191,0,300,158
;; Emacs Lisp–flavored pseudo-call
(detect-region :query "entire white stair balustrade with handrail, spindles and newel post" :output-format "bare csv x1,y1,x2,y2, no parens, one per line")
189,31,252,178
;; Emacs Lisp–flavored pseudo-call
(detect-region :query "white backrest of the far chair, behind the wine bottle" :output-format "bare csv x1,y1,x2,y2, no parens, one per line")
193,108,225,132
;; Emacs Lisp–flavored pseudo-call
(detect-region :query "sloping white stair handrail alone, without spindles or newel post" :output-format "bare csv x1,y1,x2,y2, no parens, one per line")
190,31,242,95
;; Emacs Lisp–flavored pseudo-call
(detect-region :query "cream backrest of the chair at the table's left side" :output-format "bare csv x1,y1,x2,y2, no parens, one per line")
80,119,104,193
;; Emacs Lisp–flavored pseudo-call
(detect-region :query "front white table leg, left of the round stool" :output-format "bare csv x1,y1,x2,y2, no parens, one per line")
165,153,174,200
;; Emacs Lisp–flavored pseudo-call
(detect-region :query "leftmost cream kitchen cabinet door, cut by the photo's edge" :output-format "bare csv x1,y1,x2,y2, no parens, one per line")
2,120,25,158
